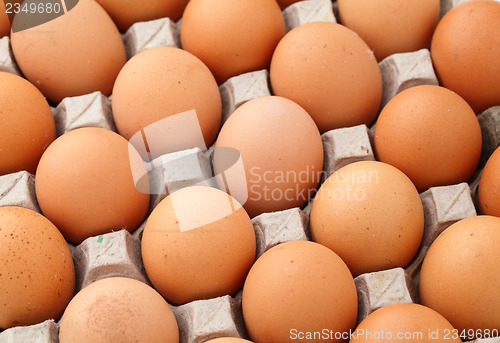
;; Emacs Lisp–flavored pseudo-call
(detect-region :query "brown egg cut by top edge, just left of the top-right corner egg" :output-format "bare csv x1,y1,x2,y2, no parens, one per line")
337,0,440,61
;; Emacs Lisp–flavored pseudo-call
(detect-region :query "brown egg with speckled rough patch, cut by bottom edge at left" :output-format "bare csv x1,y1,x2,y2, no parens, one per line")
59,277,179,343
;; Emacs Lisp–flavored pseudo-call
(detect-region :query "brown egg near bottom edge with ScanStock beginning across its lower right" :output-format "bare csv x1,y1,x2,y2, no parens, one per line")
242,241,358,343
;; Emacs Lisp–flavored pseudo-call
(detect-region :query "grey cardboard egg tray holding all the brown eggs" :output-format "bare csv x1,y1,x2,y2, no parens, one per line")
0,0,500,343
